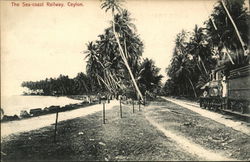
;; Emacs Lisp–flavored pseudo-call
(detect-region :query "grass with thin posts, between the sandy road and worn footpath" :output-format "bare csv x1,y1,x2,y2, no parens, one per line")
1,102,197,161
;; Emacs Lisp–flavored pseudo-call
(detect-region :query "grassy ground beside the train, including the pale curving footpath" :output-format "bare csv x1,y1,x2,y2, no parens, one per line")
144,101,250,161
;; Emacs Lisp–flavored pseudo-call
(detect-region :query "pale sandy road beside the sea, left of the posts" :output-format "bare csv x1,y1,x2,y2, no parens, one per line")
1,100,119,138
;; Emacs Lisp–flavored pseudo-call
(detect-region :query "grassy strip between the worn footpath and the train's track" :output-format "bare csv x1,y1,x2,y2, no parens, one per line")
147,101,250,160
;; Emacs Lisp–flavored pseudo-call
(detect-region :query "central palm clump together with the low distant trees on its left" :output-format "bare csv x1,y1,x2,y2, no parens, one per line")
22,0,162,99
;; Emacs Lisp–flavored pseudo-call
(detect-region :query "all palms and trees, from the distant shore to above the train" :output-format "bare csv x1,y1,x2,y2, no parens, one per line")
22,0,249,99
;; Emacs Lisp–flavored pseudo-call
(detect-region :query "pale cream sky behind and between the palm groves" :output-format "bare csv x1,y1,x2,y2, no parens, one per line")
0,0,216,95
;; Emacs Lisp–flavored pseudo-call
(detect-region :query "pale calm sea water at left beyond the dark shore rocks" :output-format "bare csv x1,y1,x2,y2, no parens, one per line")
1,95,82,115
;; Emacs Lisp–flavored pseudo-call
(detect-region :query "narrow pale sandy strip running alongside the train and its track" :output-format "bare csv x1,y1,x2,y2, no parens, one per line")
162,97,250,135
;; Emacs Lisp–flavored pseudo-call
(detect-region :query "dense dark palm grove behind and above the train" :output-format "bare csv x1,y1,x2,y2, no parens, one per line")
162,0,250,97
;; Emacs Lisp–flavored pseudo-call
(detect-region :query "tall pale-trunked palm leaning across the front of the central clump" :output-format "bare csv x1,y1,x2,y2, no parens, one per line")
101,0,143,100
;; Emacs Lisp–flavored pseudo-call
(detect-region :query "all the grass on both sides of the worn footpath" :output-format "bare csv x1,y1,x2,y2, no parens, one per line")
1,101,250,161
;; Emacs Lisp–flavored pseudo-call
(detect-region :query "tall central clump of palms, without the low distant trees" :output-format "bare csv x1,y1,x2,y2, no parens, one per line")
85,0,162,99
